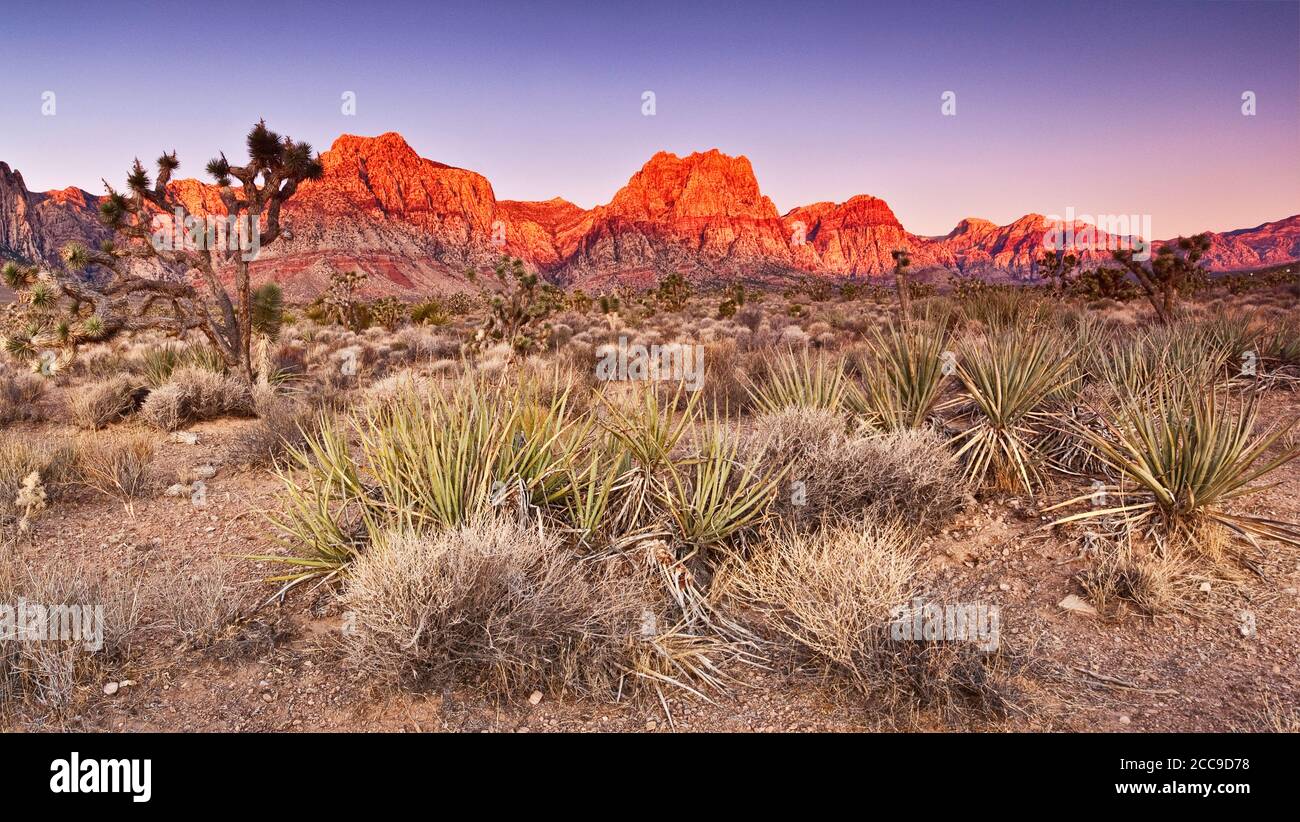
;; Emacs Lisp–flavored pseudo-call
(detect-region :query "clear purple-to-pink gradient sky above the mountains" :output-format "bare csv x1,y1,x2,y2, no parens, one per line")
0,0,1300,238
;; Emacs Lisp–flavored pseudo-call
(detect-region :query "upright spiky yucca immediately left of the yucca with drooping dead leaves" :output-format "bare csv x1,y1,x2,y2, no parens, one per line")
845,323,950,431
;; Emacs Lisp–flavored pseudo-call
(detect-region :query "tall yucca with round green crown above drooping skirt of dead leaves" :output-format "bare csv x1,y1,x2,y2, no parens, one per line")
953,330,1078,493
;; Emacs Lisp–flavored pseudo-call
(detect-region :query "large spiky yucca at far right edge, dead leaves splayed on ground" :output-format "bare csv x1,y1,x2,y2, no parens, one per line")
1053,381,1300,546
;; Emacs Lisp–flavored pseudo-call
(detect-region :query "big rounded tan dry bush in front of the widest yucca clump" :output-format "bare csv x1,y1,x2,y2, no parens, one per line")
343,520,646,697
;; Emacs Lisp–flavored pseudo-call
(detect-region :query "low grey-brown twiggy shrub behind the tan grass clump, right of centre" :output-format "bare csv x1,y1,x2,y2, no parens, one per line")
750,408,969,527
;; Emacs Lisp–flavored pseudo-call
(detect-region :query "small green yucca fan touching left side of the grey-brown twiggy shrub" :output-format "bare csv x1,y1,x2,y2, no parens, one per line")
663,420,788,549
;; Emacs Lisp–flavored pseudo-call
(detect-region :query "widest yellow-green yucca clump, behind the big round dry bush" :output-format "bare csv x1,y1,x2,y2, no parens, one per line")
270,378,579,577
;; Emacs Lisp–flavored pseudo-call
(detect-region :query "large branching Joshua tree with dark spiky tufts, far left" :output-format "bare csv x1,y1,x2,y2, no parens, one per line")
4,122,322,382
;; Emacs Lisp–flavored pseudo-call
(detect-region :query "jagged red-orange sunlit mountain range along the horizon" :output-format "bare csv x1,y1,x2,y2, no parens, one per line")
0,131,1300,298
